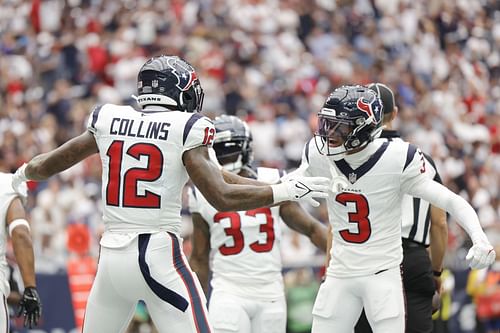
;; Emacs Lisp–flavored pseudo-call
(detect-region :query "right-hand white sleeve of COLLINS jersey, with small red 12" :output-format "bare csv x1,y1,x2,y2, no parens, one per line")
182,113,215,151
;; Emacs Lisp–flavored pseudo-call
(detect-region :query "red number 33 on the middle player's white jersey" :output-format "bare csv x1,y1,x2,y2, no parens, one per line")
214,208,275,256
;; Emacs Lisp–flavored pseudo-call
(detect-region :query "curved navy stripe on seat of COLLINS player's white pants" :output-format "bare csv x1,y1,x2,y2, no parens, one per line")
139,234,189,312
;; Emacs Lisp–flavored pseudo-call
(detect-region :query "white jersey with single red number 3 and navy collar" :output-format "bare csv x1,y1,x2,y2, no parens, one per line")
301,139,428,278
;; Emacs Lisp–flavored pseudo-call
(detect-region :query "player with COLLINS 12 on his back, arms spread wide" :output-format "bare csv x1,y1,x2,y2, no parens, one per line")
12,56,328,333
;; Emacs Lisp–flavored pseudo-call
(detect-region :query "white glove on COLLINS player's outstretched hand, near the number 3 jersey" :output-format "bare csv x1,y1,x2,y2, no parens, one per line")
271,177,330,207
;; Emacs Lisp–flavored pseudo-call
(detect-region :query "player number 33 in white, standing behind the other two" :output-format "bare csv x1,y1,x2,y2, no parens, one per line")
189,115,327,333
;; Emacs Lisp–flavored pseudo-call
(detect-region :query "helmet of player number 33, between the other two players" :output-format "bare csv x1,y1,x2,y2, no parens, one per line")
213,115,253,173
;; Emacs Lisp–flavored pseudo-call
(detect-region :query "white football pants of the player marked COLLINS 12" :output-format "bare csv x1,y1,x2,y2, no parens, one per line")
83,232,212,333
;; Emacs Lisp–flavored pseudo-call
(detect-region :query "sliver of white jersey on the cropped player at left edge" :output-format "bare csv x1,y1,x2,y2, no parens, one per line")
0,172,18,297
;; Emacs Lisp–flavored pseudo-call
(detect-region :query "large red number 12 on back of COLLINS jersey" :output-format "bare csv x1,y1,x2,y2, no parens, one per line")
106,140,163,208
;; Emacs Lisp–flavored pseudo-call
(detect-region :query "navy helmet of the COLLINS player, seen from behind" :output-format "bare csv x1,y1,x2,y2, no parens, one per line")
137,55,204,112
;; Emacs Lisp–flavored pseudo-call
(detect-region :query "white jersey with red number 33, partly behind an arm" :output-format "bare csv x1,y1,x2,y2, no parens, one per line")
189,168,284,299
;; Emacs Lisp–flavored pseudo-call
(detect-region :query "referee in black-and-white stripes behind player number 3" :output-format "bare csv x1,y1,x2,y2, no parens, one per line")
355,83,448,333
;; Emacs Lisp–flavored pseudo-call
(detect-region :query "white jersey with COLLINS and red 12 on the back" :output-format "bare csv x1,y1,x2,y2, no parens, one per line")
87,104,215,247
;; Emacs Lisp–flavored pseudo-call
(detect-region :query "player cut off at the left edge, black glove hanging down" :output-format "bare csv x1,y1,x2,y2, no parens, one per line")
0,172,42,332
